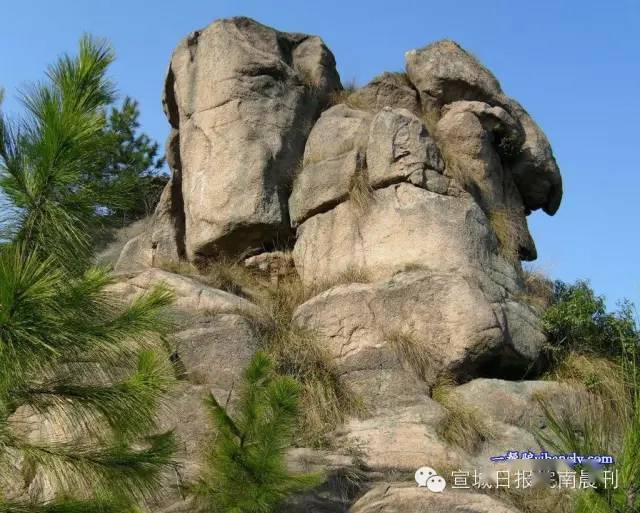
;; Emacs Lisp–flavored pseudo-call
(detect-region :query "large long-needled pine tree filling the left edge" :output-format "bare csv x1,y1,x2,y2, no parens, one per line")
0,37,173,513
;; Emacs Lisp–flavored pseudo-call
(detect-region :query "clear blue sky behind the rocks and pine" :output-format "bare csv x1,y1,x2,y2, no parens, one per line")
0,0,640,306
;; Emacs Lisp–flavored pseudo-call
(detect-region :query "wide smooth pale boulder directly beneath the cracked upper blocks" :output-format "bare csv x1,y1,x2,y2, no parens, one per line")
293,182,504,283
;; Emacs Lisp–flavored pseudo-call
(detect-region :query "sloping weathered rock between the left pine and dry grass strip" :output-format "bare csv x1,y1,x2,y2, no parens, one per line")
111,269,259,498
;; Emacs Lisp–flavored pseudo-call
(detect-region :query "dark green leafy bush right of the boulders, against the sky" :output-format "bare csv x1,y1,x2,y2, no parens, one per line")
543,281,640,356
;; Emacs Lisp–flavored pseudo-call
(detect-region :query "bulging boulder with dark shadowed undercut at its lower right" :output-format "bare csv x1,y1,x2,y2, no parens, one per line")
294,270,544,386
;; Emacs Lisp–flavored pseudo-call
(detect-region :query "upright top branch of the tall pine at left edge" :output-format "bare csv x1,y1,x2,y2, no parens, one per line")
0,33,114,265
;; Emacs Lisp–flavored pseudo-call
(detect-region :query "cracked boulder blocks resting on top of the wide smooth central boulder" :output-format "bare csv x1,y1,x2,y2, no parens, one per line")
289,104,449,226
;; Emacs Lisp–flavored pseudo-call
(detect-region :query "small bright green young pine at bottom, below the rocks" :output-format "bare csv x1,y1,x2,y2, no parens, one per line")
194,352,318,513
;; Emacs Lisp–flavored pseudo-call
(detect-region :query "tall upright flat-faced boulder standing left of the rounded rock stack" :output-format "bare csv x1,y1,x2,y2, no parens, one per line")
119,18,341,268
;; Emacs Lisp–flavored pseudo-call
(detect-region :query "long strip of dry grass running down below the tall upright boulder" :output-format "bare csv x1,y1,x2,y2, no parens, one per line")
162,254,371,447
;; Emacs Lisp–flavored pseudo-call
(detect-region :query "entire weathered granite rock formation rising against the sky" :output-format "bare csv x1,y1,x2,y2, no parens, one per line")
115,18,566,513
